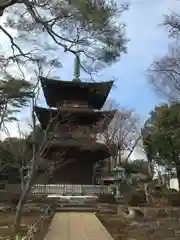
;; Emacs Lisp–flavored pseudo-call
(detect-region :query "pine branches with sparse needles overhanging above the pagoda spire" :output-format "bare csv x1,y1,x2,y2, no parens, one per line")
0,0,127,71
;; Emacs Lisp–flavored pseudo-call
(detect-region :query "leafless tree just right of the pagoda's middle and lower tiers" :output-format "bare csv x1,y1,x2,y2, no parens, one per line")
103,100,141,170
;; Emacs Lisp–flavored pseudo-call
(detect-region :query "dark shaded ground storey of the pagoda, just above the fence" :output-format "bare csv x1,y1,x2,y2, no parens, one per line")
35,156,98,185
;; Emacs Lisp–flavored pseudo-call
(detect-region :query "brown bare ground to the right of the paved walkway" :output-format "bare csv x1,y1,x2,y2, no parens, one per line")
98,209,180,240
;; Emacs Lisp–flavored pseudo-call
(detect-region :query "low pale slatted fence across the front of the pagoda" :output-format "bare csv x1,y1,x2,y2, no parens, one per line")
32,184,108,196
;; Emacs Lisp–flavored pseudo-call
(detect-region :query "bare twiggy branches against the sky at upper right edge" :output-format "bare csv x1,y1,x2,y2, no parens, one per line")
147,9,180,102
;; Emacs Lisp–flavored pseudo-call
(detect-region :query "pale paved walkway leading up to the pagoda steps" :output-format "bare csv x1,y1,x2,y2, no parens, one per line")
45,212,113,240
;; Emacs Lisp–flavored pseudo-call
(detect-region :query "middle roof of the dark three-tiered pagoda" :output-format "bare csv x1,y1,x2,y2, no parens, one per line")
35,106,117,130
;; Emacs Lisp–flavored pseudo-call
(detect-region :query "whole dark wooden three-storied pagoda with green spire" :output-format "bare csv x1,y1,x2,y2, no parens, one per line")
35,56,116,184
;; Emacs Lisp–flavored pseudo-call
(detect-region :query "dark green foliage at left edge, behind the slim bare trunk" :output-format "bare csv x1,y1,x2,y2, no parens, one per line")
0,125,46,183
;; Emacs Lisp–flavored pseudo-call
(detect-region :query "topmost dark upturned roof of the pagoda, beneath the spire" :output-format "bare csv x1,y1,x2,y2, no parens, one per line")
40,77,114,109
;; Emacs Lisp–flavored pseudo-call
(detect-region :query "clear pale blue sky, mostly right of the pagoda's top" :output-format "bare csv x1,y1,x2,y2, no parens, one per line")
0,0,180,144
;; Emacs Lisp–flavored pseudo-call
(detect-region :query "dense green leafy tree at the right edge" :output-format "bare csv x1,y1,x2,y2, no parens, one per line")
144,103,180,186
